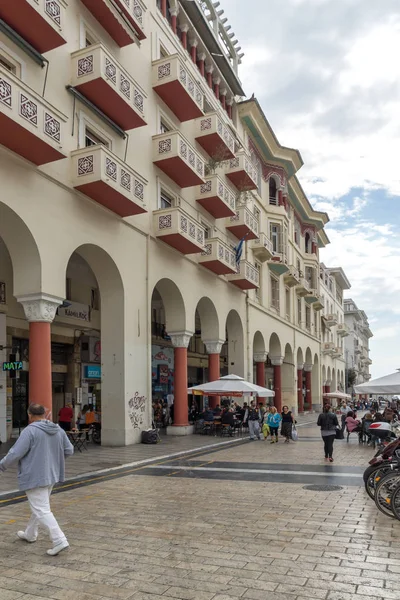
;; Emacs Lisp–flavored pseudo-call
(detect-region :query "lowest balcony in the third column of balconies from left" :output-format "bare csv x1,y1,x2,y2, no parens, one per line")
153,207,204,254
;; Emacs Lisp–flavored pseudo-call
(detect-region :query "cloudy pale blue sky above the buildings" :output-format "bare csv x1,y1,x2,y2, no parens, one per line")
227,0,400,377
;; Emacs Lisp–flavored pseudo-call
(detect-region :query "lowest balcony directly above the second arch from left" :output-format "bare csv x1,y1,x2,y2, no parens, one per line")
71,145,147,217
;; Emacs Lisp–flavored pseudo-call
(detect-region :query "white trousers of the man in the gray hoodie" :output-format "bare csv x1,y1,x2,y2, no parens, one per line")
25,485,67,546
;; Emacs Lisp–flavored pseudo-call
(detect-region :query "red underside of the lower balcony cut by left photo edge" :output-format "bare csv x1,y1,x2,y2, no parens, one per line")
0,114,65,166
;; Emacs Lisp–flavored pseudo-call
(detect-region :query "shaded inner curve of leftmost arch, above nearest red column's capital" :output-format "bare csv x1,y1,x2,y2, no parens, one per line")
0,202,41,297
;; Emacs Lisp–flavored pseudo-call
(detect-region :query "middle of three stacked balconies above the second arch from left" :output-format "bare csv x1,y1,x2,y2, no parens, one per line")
71,43,146,131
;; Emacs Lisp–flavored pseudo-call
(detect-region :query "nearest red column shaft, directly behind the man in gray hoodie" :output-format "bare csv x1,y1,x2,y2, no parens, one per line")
29,323,53,421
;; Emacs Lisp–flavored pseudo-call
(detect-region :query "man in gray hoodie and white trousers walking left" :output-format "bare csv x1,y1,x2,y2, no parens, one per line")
0,404,74,556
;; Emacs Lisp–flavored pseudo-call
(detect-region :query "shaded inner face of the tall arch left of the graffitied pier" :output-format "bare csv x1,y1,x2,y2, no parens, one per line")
64,244,126,446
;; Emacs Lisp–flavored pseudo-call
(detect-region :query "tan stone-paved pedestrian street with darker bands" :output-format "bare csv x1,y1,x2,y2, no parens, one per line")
0,417,400,600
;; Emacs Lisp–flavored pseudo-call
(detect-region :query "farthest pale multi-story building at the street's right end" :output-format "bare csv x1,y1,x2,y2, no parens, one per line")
344,298,373,393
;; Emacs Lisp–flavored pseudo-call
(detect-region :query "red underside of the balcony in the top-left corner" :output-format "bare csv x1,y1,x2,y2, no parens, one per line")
0,0,66,54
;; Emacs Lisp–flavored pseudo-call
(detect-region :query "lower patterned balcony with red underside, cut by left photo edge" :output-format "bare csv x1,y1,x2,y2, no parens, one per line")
0,66,66,165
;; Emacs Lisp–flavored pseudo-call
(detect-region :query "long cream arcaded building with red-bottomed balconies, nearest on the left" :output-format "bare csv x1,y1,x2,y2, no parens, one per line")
0,0,328,445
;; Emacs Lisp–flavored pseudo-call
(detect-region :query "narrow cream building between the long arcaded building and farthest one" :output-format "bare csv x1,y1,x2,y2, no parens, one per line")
319,264,351,393
